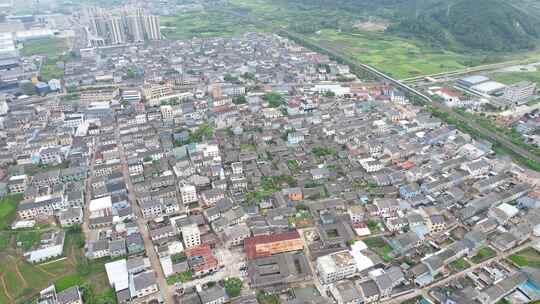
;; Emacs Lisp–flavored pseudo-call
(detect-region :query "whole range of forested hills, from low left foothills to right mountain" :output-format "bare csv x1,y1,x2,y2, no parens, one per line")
255,0,540,51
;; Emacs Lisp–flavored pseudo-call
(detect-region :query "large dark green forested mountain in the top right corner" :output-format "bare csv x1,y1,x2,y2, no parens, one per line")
388,0,540,51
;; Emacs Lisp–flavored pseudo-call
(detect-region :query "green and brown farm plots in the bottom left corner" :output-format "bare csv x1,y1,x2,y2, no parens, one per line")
0,227,114,303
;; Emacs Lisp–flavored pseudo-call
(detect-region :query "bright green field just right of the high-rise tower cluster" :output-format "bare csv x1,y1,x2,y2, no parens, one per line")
160,9,261,39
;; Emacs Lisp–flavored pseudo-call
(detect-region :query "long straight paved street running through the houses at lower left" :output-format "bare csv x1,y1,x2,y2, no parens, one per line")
115,127,174,304
